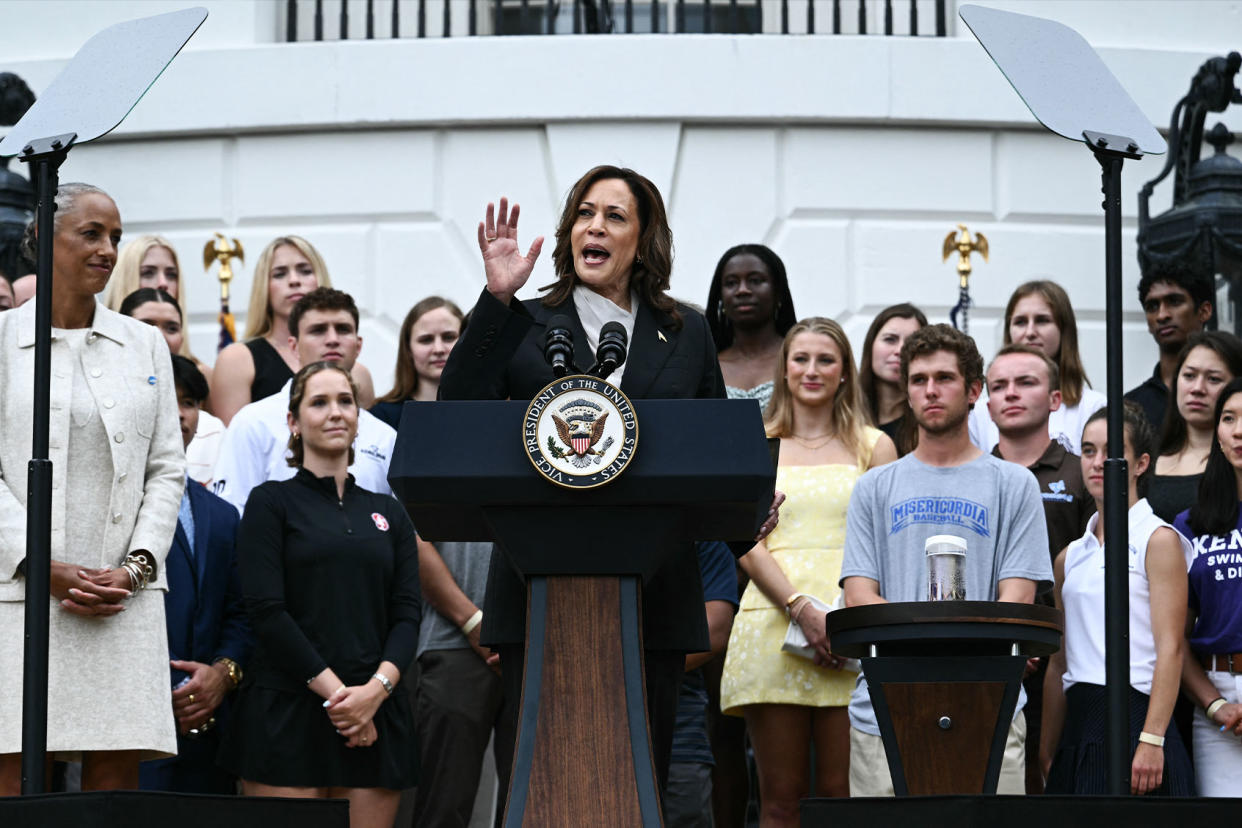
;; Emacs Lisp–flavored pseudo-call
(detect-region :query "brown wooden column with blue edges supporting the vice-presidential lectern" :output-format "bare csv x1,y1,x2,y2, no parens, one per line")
504,576,662,828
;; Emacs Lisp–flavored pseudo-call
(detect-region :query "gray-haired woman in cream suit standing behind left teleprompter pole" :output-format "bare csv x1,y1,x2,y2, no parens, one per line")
0,184,185,794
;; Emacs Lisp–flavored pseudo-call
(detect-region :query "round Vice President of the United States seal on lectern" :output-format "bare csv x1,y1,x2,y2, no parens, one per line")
522,375,638,489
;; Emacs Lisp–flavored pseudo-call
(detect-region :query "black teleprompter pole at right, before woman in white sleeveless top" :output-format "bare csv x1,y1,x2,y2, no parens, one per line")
1083,132,1141,796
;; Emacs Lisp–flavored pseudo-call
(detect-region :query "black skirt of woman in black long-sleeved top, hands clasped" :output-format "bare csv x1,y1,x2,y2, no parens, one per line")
220,684,419,791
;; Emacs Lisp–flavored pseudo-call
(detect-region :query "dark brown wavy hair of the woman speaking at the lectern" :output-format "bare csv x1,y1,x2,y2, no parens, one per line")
539,164,682,329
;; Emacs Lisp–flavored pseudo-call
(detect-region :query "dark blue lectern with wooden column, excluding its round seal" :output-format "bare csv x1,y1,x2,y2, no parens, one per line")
389,400,775,828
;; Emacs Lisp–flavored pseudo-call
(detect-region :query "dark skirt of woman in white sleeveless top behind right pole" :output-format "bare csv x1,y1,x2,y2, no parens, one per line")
1043,684,1195,797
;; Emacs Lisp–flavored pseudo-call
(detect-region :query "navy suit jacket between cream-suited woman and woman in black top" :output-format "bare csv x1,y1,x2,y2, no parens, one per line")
164,483,253,680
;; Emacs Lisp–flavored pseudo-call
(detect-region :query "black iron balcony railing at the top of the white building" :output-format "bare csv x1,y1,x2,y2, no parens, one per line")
284,0,946,42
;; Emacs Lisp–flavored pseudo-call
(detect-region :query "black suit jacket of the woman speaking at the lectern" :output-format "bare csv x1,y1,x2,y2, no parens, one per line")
440,289,724,652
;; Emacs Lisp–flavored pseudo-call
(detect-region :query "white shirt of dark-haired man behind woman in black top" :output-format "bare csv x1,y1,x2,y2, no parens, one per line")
211,380,396,511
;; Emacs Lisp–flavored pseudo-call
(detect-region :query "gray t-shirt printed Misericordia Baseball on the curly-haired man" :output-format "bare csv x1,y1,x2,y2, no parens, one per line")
841,454,1052,735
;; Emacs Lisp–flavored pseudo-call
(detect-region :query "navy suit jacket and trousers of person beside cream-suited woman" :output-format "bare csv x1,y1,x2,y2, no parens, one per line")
140,480,253,793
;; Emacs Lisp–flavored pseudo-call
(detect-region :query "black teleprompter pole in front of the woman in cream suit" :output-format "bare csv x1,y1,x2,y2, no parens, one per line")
21,133,77,794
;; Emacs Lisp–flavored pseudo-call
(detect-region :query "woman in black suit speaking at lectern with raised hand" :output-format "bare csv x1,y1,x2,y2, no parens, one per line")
440,166,724,788
